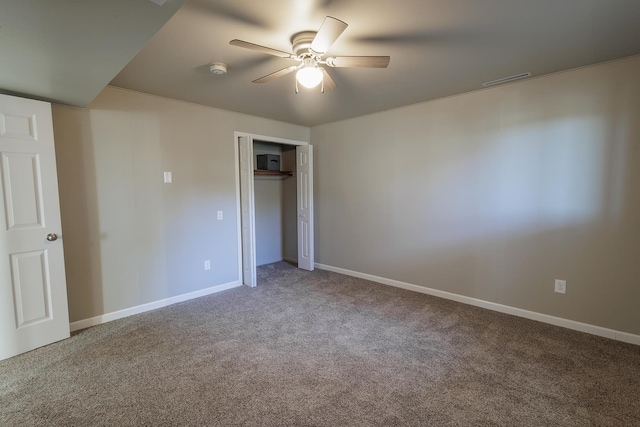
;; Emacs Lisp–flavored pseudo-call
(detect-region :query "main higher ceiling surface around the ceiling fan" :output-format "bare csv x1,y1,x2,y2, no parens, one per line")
112,0,640,126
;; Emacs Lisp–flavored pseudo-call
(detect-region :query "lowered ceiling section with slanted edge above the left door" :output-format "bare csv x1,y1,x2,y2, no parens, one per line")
0,0,186,107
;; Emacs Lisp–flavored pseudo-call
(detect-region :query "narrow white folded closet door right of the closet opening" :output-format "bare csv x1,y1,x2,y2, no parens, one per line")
296,145,314,271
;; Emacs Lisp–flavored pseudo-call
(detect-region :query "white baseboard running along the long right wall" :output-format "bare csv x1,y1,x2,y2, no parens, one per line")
315,263,640,345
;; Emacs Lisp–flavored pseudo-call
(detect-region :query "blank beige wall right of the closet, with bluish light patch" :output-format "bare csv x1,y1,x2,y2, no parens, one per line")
311,57,640,334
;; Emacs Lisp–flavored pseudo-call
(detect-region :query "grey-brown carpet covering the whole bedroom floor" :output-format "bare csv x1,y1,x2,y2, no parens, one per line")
0,262,640,427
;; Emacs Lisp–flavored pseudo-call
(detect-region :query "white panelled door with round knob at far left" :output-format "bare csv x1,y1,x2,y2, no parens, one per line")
0,95,69,359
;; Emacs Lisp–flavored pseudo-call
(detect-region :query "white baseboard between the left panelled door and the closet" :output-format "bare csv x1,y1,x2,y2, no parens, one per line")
69,280,242,332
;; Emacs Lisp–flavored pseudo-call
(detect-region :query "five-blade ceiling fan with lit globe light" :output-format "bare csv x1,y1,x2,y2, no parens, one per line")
229,16,391,93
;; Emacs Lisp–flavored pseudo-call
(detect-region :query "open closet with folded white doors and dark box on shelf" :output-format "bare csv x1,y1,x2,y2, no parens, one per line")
235,132,314,287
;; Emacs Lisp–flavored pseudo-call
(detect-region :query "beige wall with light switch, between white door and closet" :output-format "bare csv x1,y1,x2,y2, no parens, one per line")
53,87,309,321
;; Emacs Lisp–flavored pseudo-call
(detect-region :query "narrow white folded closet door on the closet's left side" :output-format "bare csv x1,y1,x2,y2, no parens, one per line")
238,136,256,288
